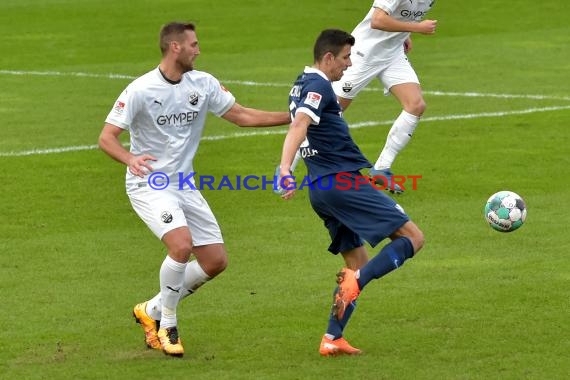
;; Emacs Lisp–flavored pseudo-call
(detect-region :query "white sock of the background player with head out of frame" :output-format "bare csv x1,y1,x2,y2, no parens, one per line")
374,111,420,169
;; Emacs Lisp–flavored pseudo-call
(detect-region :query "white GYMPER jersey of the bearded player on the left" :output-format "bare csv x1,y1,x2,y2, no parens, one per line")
105,67,235,191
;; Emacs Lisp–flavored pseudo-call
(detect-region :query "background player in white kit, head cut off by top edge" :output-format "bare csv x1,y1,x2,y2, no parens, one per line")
333,0,437,193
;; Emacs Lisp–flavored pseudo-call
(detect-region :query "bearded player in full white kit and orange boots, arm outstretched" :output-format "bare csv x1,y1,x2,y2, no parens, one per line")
99,22,290,356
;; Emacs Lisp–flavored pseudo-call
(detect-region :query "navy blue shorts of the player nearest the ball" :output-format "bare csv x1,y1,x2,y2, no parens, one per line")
309,172,410,255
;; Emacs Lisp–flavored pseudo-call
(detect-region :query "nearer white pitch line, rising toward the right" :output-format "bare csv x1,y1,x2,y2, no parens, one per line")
0,105,570,157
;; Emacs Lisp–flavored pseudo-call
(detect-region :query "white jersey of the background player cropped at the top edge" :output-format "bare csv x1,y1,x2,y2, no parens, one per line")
352,0,435,64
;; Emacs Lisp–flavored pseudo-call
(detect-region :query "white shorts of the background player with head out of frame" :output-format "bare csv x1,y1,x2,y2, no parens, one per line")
332,53,420,99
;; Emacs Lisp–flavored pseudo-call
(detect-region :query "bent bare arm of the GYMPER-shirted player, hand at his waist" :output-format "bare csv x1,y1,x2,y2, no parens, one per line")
99,123,156,178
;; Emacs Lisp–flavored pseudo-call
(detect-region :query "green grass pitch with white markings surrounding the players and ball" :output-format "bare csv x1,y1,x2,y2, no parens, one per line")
0,0,570,380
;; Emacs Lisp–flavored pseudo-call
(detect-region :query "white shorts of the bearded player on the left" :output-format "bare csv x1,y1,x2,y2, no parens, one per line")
127,187,224,247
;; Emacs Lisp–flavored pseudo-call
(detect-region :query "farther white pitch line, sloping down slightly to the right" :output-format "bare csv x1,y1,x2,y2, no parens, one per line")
0,70,570,101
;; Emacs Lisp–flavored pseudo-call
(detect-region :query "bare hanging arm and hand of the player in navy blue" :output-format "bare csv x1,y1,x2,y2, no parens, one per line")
279,112,311,199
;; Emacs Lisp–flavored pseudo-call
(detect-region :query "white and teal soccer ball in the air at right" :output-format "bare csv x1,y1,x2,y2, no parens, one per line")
484,191,526,232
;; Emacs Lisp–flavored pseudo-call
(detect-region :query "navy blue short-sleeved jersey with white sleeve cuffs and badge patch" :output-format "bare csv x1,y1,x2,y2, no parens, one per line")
289,67,372,181
